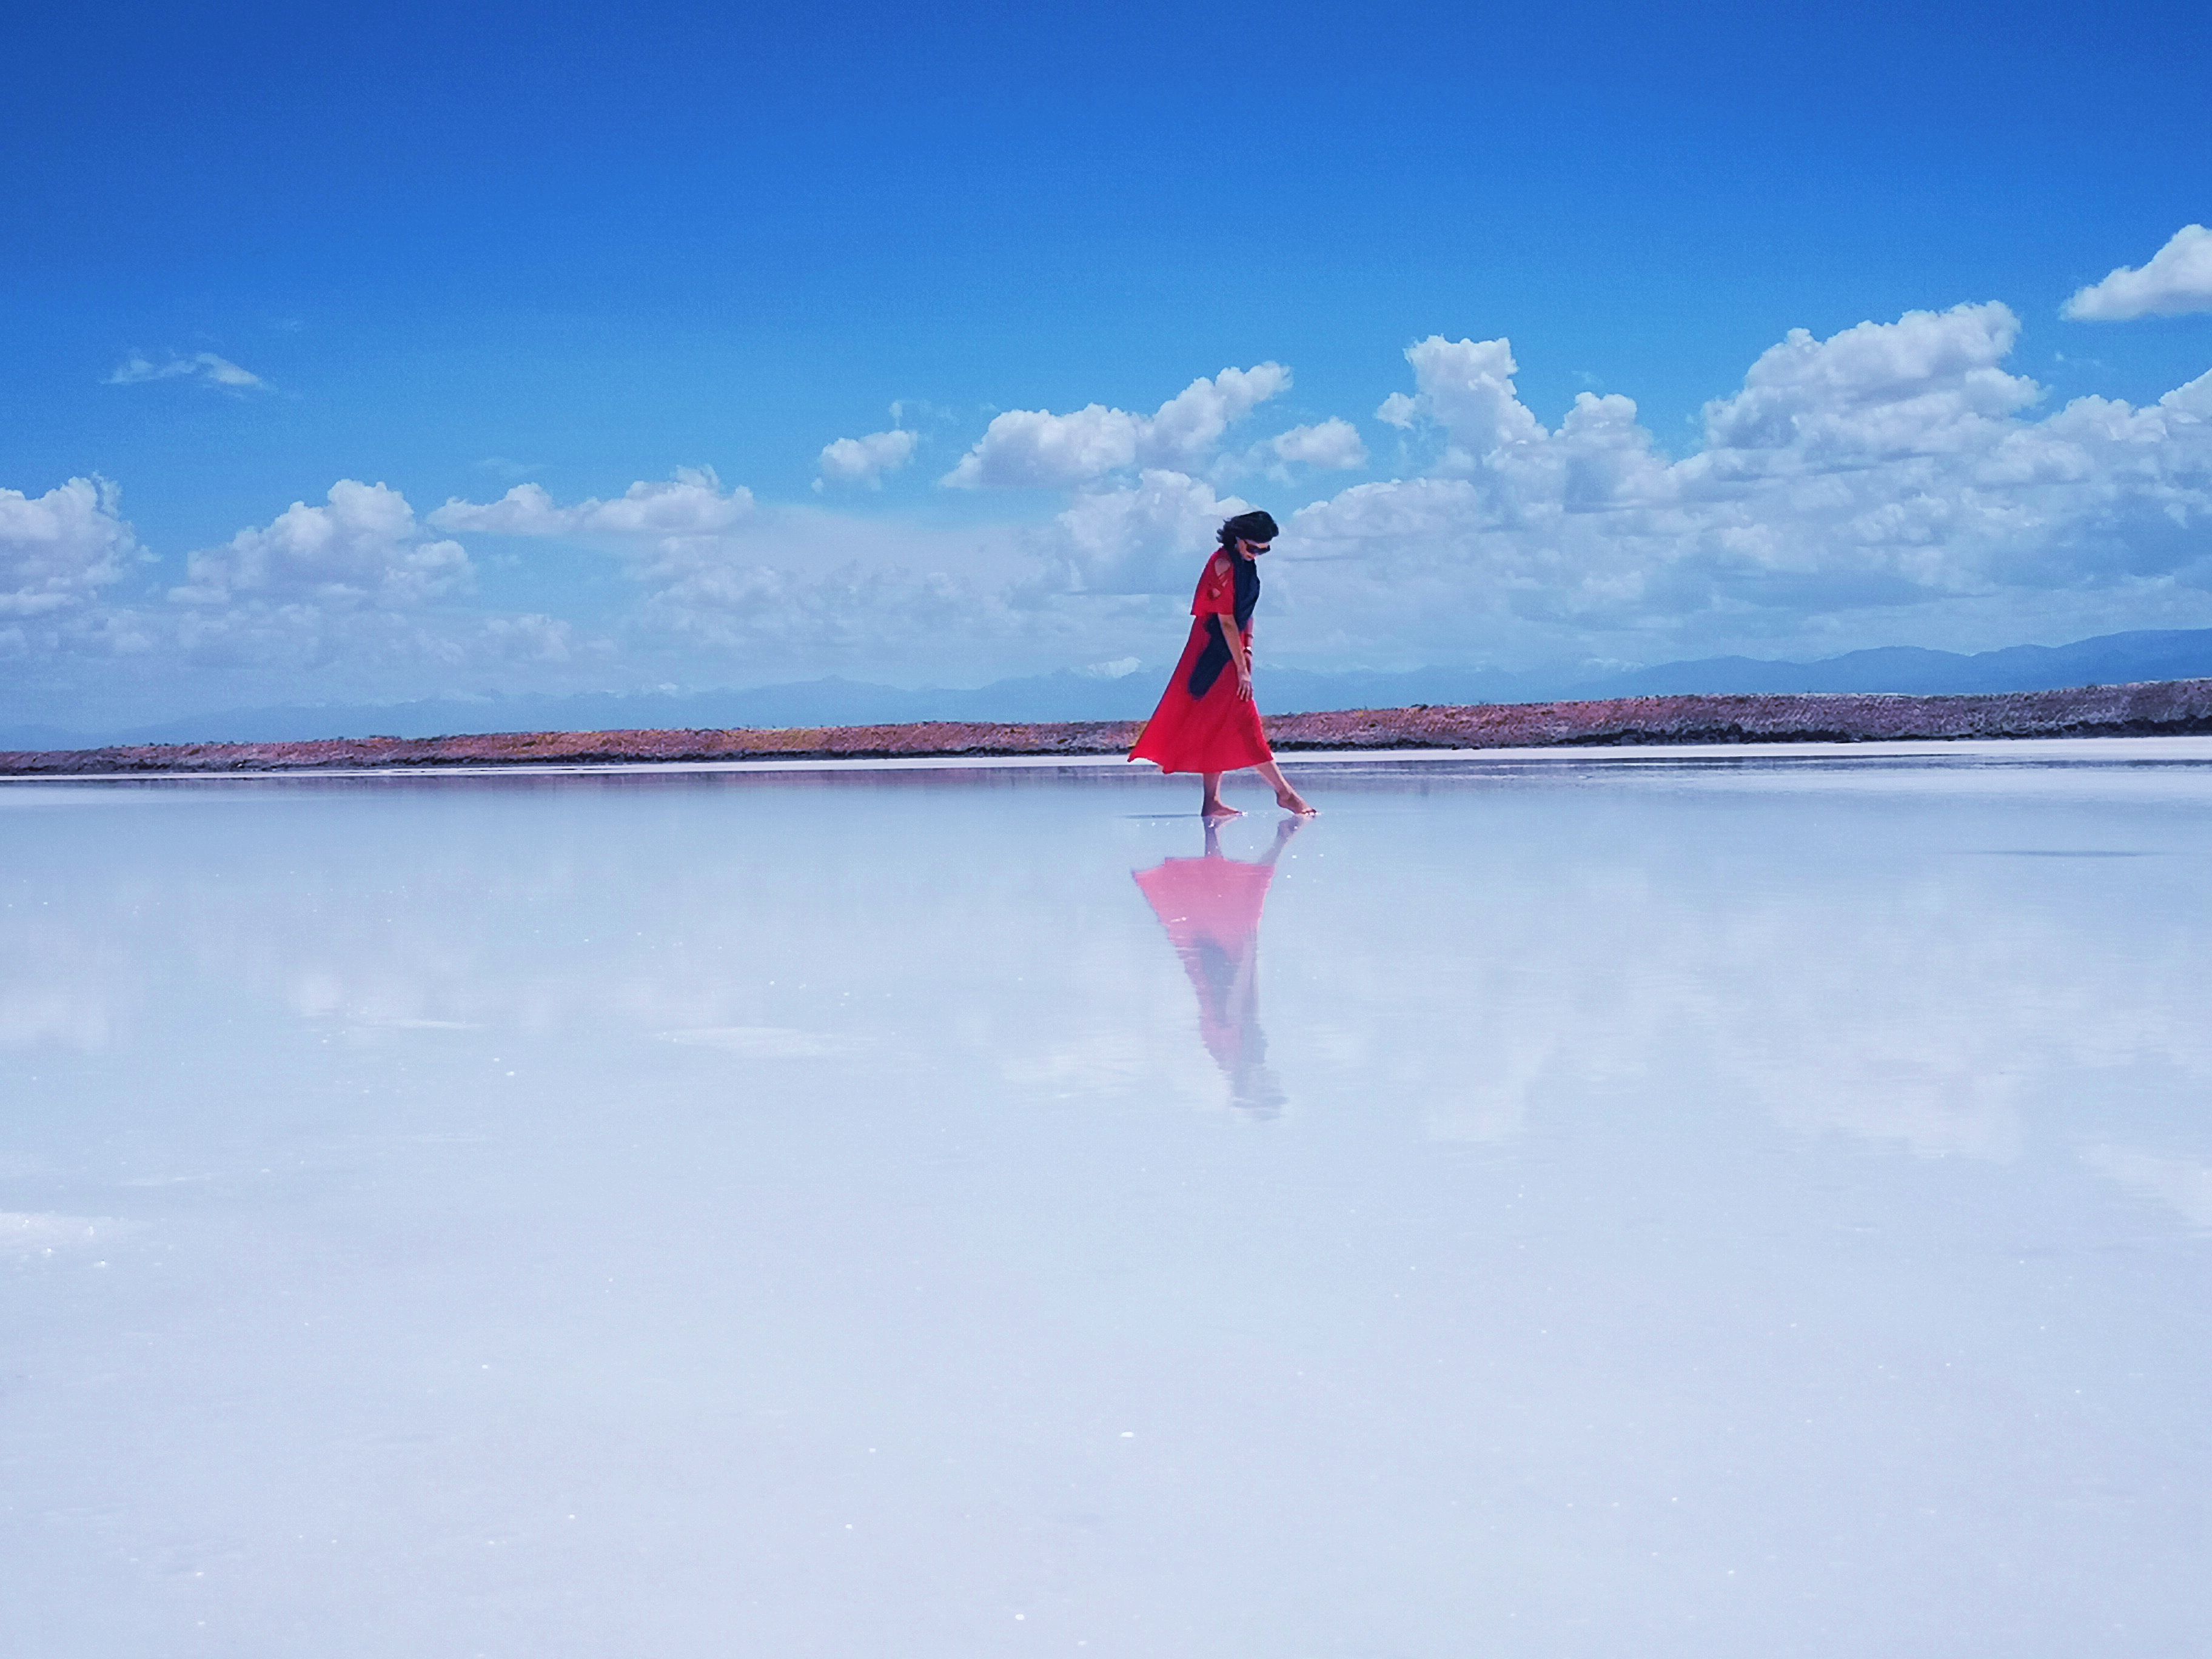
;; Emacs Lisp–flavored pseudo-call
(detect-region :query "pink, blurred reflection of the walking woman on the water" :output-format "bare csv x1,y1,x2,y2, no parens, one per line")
1130,819,1303,1117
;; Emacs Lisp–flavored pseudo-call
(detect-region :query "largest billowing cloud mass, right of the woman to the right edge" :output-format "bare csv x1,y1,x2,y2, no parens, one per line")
1285,303,2212,662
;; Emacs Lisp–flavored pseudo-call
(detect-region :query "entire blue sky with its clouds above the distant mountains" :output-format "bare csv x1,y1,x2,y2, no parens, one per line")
0,4,2212,726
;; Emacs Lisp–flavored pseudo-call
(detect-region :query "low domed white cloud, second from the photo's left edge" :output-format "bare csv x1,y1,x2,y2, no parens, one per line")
170,478,474,608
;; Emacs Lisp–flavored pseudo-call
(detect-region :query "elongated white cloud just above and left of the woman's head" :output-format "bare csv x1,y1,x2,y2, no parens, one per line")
940,363,1290,489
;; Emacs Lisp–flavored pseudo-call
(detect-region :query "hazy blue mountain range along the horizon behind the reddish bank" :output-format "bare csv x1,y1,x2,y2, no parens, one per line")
13,628,2212,750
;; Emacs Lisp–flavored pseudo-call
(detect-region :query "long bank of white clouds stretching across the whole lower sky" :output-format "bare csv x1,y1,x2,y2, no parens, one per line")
13,305,2212,734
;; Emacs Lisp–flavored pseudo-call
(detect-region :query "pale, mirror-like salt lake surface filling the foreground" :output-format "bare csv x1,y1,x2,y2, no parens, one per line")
0,739,2212,1659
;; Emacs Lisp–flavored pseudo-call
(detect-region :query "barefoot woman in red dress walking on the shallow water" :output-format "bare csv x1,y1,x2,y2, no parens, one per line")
1128,513,1314,819
